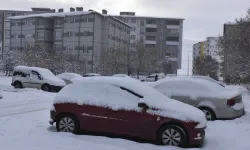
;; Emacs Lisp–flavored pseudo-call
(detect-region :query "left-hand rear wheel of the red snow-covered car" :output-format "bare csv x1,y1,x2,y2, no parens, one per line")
56,114,80,134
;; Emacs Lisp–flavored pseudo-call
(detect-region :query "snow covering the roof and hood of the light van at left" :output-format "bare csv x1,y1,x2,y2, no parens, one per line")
14,66,66,86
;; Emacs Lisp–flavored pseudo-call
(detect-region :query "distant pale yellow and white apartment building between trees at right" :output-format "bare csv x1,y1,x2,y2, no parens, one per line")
193,37,224,81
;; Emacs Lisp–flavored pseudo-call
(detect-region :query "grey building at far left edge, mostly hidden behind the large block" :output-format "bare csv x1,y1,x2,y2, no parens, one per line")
0,8,55,58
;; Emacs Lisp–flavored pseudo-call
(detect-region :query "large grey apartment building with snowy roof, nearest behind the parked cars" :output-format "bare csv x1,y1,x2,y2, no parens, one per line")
9,7,130,72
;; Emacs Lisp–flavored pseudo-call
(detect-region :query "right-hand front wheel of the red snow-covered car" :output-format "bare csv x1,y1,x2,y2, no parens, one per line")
157,125,188,148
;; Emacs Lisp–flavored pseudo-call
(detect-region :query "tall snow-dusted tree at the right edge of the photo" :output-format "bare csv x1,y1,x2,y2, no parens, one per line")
220,9,250,83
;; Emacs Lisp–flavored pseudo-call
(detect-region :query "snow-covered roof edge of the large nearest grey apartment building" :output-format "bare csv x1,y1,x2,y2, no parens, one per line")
8,11,130,27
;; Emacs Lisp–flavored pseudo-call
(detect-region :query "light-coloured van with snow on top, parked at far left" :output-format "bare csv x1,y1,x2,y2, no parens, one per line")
11,66,66,92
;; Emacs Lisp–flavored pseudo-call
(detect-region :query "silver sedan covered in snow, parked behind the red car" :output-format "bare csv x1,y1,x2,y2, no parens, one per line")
150,77,245,120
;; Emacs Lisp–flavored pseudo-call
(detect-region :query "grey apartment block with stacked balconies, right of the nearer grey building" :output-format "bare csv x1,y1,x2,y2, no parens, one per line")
114,12,184,74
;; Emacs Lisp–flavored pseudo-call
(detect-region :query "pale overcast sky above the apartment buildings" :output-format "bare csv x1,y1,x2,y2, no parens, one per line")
0,0,250,74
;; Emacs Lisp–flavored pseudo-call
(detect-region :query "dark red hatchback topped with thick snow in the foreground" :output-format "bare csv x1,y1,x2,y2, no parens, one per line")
50,77,207,147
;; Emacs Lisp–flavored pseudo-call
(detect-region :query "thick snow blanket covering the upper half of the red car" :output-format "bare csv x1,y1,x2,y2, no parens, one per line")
54,77,206,127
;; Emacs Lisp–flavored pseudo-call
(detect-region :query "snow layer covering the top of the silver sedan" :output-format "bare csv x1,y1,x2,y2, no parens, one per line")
150,77,241,100
